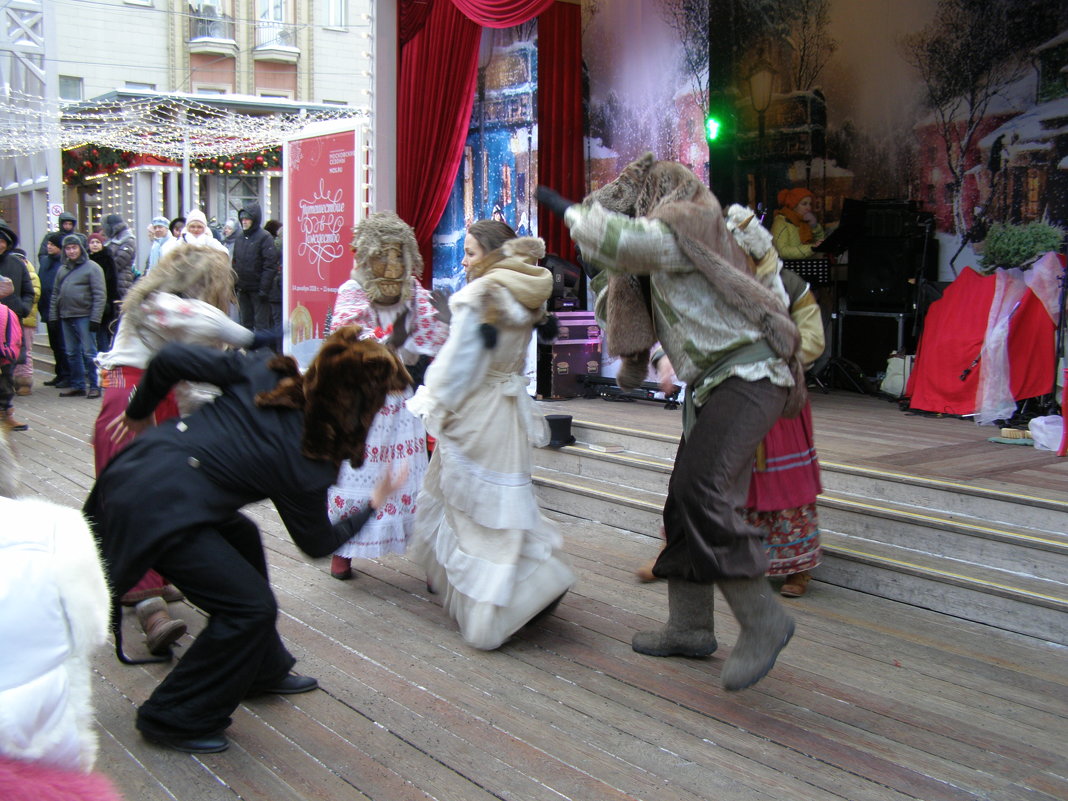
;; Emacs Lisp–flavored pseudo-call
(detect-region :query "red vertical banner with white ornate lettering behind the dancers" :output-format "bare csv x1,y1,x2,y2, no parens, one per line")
283,124,364,368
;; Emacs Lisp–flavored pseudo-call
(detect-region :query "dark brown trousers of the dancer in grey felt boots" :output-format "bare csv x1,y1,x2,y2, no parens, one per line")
653,377,788,583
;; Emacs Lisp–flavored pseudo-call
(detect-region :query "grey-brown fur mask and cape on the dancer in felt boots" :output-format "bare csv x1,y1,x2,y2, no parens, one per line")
585,153,806,417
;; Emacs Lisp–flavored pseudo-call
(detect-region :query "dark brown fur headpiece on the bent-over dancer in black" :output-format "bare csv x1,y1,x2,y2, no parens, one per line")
256,326,411,467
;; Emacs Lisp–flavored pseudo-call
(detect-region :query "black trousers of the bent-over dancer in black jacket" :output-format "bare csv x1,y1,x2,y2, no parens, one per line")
137,514,297,737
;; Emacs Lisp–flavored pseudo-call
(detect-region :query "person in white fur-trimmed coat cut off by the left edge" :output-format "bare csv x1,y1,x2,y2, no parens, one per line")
0,434,120,801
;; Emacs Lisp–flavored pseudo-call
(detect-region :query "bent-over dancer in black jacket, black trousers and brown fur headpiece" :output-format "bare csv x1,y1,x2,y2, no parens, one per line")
84,326,410,753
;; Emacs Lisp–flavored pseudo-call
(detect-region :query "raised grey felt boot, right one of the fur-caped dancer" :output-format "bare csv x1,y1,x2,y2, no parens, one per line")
720,576,794,690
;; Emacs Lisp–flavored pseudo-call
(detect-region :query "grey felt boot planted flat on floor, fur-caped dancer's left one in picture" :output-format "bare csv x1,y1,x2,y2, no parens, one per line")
630,579,717,657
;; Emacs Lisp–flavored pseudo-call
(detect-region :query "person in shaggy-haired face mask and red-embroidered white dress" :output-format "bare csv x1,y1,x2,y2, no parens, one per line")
328,211,449,580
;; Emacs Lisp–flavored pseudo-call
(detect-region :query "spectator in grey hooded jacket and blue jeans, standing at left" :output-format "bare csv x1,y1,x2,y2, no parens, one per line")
48,234,107,397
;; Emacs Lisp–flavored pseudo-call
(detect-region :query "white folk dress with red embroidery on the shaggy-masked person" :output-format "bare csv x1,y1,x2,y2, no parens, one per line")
328,279,449,559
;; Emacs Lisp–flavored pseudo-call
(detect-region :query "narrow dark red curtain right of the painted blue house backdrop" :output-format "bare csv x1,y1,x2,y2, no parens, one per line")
531,3,586,267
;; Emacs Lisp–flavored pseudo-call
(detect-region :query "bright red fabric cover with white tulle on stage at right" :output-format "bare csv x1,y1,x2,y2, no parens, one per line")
906,268,1055,414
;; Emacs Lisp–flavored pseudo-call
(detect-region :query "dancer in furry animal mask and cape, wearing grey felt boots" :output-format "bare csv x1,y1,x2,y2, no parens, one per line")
538,153,805,690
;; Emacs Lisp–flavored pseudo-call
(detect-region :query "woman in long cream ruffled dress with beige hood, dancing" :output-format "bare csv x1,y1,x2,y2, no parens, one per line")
408,220,576,650
